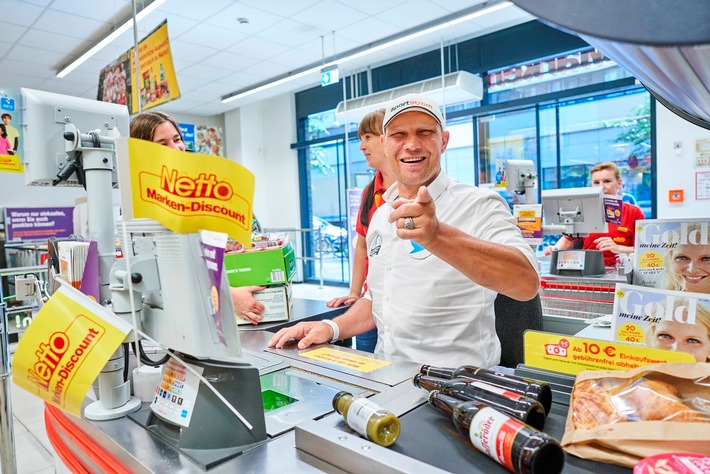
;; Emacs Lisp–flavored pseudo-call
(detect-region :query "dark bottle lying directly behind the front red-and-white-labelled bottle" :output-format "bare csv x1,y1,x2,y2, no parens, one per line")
412,374,545,430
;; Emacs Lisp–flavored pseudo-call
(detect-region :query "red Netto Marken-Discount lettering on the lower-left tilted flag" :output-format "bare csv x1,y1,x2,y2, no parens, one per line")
28,328,101,403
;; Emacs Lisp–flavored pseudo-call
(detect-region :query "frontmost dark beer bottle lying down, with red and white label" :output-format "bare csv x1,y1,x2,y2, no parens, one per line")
429,390,565,474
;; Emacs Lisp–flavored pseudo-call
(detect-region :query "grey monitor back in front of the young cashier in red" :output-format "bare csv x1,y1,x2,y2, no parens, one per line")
542,187,608,235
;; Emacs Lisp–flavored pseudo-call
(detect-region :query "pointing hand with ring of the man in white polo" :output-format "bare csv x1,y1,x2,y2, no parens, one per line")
389,186,439,247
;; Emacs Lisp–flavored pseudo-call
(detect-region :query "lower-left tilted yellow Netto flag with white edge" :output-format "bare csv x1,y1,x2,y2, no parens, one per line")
12,286,130,416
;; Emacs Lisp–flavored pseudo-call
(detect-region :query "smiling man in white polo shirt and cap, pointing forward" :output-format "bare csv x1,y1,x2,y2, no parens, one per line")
269,94,539,367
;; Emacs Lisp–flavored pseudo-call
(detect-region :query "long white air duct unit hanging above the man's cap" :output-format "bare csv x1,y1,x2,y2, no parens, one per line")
335,71,483,123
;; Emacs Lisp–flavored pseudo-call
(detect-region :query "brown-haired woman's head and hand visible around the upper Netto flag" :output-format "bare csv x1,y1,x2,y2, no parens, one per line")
131,112,264,324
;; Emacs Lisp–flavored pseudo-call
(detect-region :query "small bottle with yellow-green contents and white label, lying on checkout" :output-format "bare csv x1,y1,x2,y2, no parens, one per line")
333,391,400,447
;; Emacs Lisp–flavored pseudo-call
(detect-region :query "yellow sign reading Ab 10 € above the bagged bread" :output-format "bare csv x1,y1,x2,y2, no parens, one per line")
525,331,695,375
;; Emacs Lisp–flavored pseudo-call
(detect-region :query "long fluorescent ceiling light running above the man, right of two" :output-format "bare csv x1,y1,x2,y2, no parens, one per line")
222,1,513,104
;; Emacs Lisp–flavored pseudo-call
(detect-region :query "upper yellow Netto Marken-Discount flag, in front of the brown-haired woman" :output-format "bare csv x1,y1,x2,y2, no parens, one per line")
117,138,254,246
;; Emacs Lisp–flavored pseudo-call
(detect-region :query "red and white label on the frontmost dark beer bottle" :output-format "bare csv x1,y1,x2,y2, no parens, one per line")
469,407,524,472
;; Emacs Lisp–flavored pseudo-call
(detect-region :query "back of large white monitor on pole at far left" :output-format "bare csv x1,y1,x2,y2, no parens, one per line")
21,88,129,186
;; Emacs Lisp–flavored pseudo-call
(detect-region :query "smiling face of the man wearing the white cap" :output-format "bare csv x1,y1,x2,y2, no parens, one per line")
382,111,449,199
